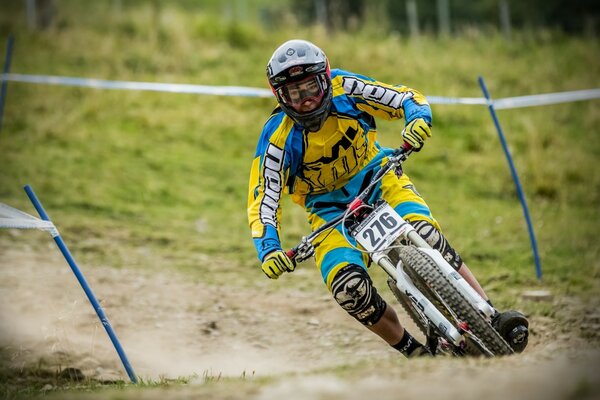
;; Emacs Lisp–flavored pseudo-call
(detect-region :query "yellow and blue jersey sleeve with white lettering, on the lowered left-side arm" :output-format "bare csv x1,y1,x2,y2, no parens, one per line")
248,112,290,261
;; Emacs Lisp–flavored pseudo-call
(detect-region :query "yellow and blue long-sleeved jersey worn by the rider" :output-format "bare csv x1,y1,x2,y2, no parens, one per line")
248,69,431,261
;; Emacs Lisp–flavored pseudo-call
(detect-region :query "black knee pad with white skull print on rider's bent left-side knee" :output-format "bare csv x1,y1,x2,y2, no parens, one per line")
331,264,387,326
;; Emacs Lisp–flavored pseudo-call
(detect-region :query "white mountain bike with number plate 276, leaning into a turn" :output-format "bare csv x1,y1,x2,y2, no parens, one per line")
286,147,513,357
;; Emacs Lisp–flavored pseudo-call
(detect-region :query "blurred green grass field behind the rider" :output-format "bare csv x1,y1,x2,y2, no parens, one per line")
0,2,600,394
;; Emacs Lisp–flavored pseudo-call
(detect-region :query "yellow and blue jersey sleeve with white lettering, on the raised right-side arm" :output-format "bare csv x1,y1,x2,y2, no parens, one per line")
332,70,432,124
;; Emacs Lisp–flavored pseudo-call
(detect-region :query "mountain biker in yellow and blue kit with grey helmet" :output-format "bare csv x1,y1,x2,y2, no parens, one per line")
248,40,528,357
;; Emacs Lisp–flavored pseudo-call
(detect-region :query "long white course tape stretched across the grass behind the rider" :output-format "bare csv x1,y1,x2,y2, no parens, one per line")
0,74,600,110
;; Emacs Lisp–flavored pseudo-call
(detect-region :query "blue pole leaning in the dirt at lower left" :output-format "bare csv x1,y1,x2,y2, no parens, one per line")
25,185,137,383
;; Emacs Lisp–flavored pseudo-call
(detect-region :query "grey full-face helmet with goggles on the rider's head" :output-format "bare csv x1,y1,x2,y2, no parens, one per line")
267,40,332,132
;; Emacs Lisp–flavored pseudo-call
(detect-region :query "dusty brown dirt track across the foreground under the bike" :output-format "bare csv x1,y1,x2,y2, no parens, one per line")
0,247,600,400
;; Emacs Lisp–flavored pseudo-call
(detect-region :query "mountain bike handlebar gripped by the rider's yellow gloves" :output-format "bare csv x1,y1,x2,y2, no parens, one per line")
285,142,413,263
